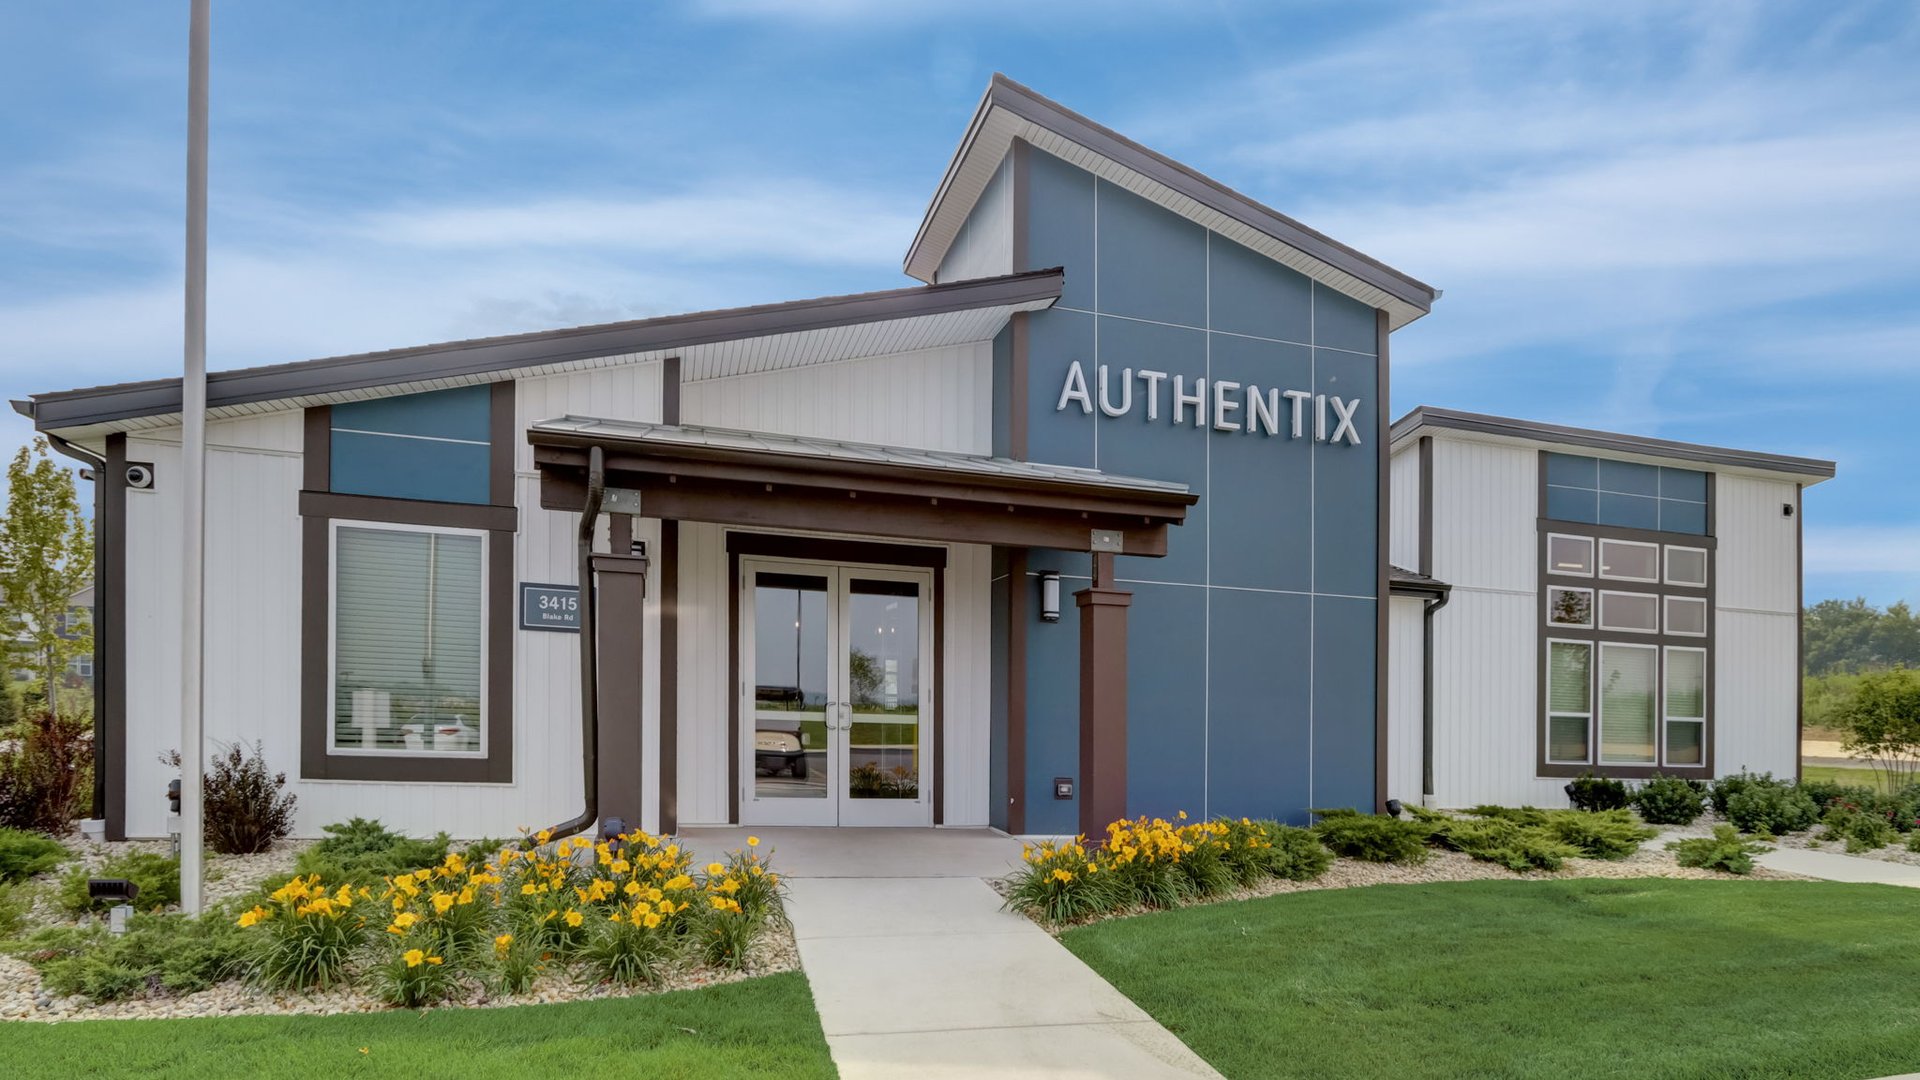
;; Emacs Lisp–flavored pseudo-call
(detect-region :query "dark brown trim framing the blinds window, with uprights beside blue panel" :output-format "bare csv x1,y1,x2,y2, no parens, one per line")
300,382,518,784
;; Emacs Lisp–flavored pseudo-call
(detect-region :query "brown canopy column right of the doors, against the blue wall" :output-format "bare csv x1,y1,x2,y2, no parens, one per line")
1073,555,1133,844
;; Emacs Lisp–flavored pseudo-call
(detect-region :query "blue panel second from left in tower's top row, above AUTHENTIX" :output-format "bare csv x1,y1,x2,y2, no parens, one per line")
1094,181,1208,327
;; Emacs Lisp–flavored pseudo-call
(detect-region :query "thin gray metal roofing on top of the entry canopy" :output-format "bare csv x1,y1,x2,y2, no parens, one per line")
526,415,1198,503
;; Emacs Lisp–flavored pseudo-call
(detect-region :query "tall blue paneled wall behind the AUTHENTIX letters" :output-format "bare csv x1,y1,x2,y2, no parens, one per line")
995,150,1386,834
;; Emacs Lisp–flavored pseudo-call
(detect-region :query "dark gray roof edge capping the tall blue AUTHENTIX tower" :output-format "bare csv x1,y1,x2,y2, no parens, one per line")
906,71,1440,313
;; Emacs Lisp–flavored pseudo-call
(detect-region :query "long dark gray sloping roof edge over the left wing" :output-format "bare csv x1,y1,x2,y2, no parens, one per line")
29,267,1066,430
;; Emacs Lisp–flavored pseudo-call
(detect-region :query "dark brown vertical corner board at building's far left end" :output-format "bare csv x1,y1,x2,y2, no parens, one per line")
94,434,127,840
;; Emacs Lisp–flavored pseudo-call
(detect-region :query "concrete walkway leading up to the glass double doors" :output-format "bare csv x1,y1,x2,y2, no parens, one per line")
684,828,1219,1080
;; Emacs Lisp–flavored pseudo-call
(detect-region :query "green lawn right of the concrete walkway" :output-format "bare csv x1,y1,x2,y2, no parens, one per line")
1062,878,1920,1080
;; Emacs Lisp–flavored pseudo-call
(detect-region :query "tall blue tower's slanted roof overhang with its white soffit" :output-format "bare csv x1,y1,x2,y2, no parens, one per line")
904,73,1440,329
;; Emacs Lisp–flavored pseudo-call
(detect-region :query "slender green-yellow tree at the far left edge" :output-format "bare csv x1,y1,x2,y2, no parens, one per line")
0,438,94,715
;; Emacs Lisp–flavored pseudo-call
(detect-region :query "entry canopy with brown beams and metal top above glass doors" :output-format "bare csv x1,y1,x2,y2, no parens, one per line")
526,417,1198,555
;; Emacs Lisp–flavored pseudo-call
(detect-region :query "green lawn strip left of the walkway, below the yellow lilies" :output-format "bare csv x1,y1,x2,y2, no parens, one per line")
0,972,833,1080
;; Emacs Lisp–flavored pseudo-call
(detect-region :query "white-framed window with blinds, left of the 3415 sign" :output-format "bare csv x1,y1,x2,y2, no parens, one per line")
332,525,486,755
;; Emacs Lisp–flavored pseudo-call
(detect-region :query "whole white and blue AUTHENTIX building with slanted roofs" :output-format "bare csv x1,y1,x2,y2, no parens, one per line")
26,77,1834,838
